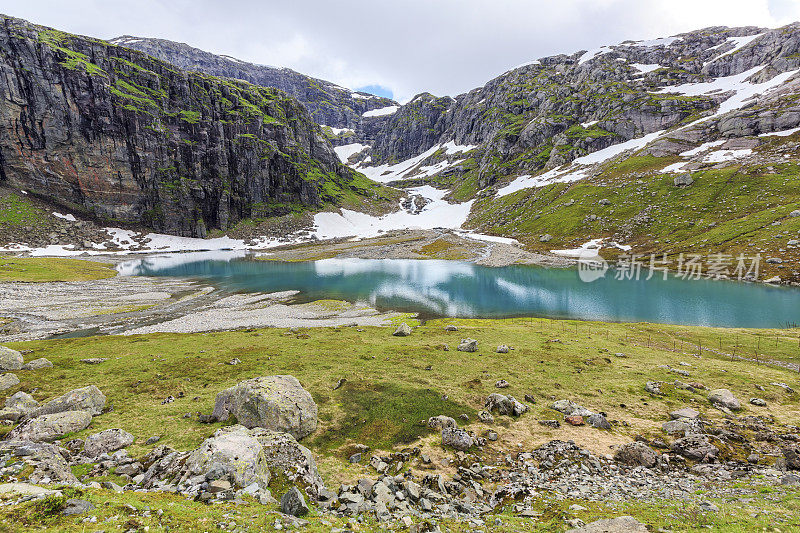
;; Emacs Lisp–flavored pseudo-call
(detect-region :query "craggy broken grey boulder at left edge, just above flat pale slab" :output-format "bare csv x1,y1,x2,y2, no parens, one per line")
0,440,78,484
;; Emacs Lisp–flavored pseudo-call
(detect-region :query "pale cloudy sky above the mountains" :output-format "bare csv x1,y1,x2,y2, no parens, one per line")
0,0,800,101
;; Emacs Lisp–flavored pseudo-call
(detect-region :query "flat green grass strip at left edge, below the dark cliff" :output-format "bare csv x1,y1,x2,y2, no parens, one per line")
0,256,117,283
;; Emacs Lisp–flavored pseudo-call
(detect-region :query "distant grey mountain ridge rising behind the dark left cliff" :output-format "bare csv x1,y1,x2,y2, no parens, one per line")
110,35,397,132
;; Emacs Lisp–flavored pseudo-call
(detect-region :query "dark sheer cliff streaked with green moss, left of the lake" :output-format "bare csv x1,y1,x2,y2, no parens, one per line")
0,16,368,237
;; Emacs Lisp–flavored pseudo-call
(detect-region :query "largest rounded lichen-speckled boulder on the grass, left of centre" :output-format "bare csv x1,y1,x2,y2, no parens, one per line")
213,376,317,439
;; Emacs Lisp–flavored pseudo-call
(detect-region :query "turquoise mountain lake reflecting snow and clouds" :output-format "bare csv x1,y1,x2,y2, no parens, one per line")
118,252,800,327
